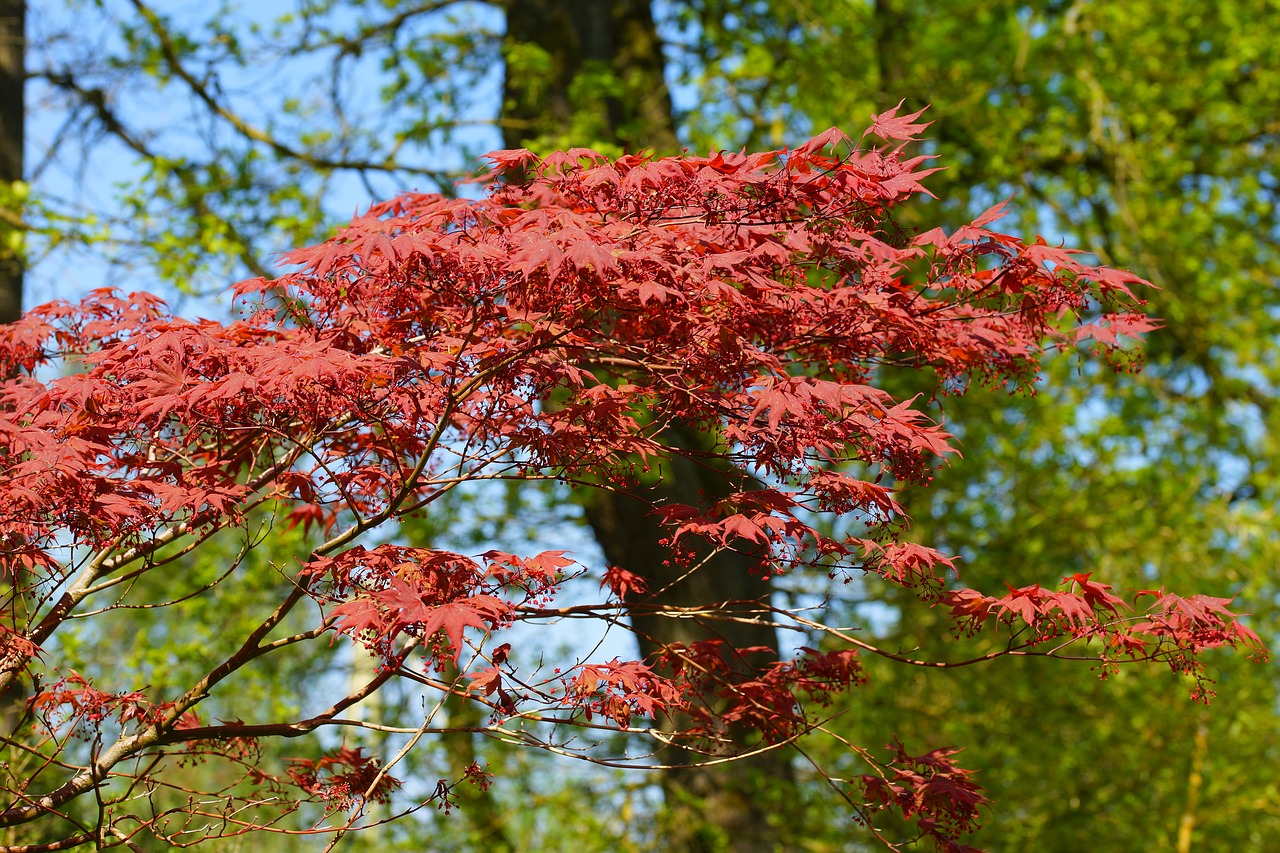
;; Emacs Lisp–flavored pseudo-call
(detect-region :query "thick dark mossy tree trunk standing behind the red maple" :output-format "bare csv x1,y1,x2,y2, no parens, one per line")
502,0,795,853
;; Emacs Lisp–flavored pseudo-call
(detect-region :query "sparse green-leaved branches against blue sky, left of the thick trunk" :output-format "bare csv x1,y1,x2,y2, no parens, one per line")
27,0,500,298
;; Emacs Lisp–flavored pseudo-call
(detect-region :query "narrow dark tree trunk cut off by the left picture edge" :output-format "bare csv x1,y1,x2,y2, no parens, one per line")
0,0,27,323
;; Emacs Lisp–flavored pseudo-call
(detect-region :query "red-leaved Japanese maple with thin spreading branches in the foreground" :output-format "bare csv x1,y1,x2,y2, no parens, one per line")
0,110,1261,850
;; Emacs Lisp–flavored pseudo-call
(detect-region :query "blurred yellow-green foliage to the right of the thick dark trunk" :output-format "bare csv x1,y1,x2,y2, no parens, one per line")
670,0,1280,852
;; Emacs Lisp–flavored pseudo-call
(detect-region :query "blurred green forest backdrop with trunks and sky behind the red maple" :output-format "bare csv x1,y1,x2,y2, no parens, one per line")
0,0,1280,853
